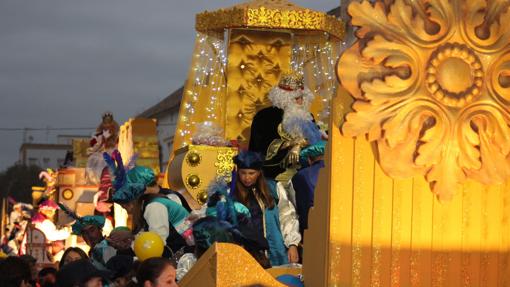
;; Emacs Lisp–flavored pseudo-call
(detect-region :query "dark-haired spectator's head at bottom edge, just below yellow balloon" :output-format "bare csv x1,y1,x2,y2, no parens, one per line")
136,257,177,287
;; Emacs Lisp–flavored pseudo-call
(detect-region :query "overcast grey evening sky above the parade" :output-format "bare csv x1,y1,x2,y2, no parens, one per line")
0,0,339,171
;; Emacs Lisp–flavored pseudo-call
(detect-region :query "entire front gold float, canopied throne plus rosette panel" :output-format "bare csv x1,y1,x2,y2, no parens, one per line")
168,0,510,286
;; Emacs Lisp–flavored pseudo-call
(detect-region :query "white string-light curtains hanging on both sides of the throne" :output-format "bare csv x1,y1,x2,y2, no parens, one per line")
178,33,341,146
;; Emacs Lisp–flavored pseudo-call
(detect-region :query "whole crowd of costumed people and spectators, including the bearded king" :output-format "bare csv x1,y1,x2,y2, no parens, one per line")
0,74,327,287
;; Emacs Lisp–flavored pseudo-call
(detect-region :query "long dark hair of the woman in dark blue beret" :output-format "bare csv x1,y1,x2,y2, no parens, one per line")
232,170,275,209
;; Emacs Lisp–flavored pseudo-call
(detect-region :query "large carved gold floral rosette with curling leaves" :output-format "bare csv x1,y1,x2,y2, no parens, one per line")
337,0,510,199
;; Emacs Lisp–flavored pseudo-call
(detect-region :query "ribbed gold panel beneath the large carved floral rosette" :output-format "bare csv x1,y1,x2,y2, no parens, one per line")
303,88,510,286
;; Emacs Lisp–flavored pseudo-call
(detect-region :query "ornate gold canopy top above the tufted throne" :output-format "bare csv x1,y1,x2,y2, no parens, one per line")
196,0,344,39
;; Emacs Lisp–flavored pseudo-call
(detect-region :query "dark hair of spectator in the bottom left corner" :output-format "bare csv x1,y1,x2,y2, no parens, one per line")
0,256,32,287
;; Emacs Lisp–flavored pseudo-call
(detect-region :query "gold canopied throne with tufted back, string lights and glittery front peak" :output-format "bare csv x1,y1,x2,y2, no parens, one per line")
166,0,344,286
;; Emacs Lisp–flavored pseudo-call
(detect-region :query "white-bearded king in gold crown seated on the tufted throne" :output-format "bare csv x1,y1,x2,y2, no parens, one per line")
249,73,327,238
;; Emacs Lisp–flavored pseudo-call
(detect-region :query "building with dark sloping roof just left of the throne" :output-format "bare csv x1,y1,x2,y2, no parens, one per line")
137,87,183,172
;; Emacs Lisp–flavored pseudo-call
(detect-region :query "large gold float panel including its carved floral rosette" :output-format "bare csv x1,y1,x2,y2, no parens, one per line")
304,0,510,287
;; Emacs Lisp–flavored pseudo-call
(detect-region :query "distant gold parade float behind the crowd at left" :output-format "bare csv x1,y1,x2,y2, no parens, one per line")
15,113,160,266
